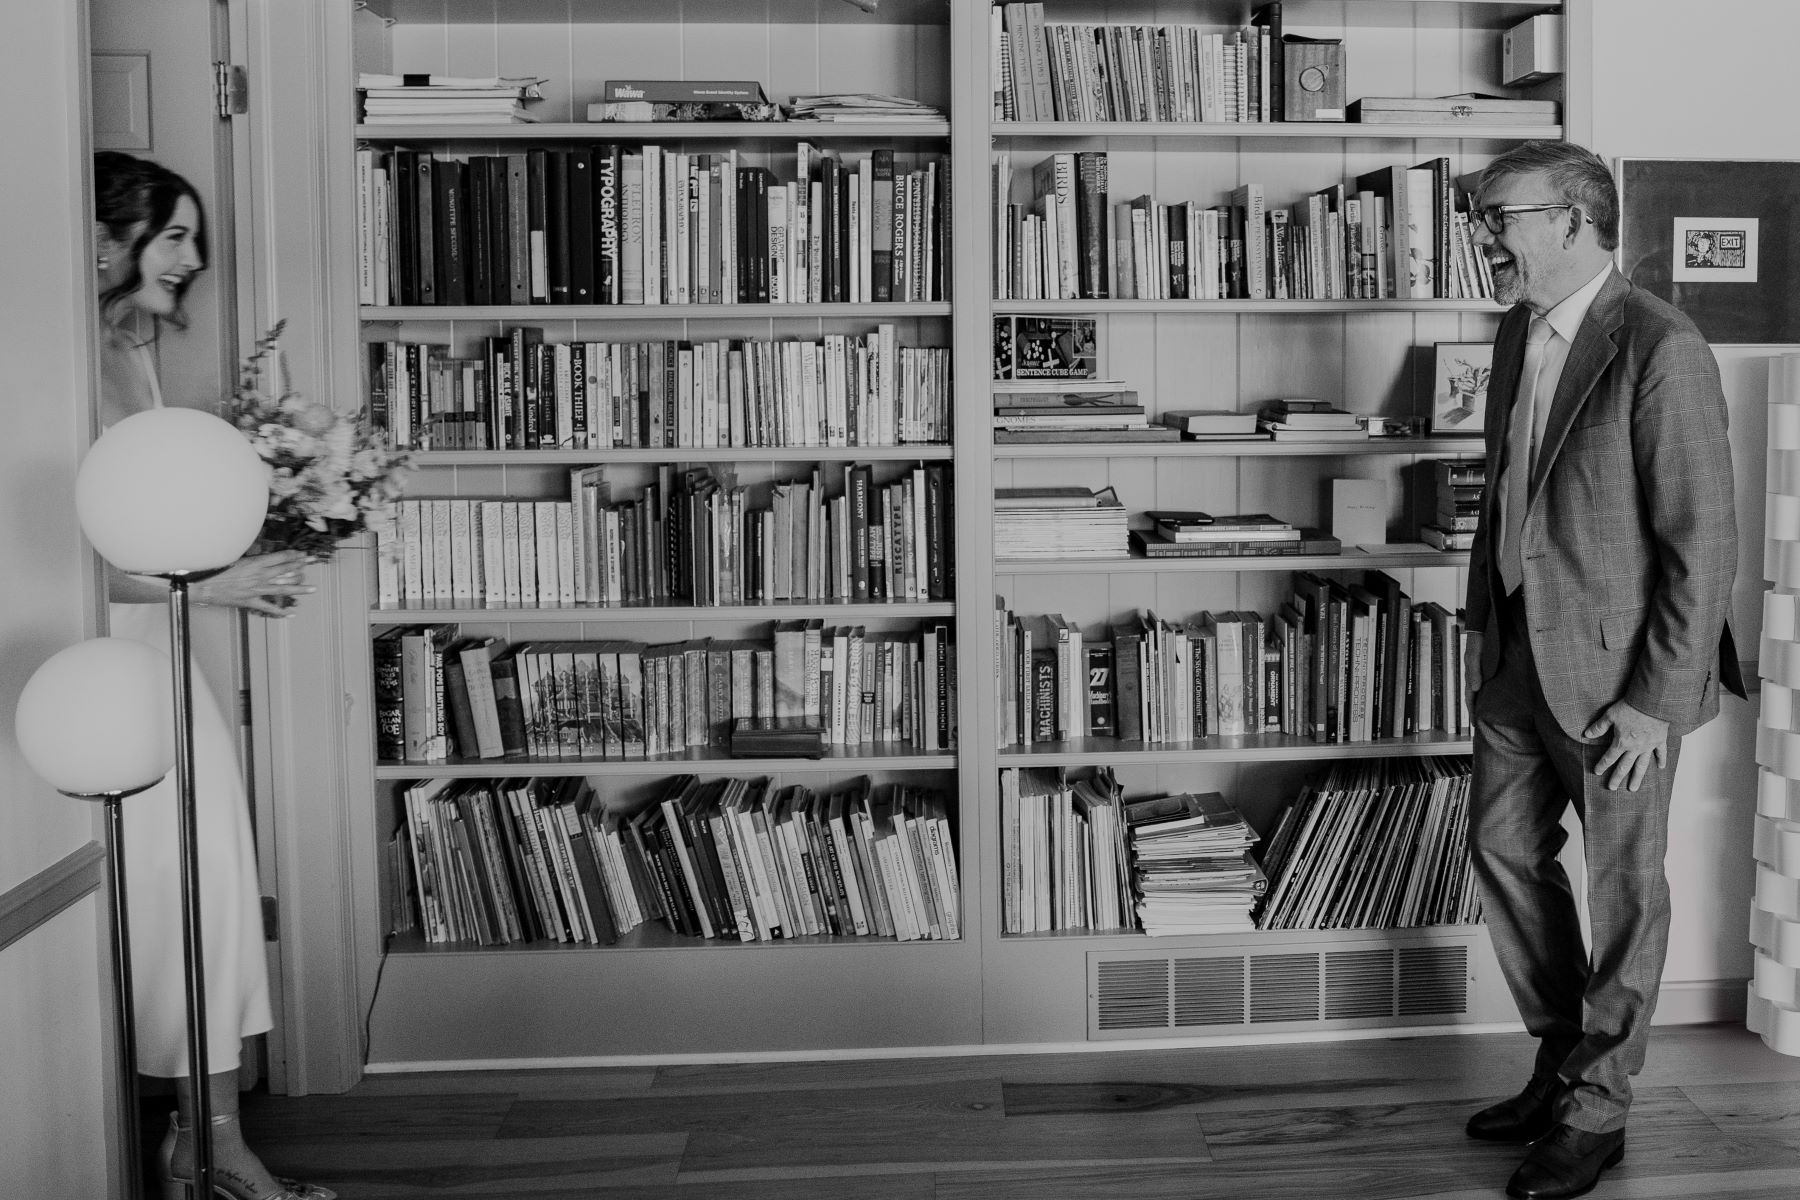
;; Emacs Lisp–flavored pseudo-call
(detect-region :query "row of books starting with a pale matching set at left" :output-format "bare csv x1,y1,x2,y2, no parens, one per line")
376,462,956,608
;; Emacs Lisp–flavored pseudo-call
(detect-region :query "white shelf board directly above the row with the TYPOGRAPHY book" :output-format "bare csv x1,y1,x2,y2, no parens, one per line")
356,121,950,144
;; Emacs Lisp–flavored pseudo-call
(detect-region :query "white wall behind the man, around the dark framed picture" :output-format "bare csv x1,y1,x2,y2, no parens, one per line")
1589,0,1800,1011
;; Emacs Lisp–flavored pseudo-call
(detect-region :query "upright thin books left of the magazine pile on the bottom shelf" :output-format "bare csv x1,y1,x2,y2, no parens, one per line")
999,766,1136,934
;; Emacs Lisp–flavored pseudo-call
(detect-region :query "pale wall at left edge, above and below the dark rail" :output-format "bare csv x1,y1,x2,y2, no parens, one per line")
0,0,112,1196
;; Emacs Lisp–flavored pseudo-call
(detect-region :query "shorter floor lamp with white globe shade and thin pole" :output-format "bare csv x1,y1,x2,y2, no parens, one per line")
13,637,175,1200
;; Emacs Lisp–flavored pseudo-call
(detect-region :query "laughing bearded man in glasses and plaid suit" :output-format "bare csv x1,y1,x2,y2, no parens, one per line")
1465,142,1742,1200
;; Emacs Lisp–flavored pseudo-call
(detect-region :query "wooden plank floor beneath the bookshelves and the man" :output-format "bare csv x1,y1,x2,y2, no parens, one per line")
189,1025,1800,1200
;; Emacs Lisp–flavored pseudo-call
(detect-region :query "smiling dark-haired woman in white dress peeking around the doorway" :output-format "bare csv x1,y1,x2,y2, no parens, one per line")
94,151,333,1200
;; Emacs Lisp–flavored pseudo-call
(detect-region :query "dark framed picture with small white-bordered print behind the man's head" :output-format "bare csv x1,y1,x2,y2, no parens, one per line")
1616,158,1800,345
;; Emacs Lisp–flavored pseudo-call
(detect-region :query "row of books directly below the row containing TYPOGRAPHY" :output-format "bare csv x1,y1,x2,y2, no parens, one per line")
369,324,952,450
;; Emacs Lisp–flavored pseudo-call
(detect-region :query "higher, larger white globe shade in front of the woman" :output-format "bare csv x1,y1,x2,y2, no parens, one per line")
76,408,268,576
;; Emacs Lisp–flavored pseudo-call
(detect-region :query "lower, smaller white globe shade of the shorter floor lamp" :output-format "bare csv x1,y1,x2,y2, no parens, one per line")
13,637,175,795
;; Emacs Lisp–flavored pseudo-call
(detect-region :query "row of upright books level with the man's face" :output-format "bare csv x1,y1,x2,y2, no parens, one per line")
992,151,1494,300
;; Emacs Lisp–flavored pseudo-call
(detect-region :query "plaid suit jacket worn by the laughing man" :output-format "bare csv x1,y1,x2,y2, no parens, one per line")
1467,272,1744,738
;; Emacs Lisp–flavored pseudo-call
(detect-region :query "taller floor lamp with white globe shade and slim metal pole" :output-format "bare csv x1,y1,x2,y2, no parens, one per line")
76,408,268,1198
